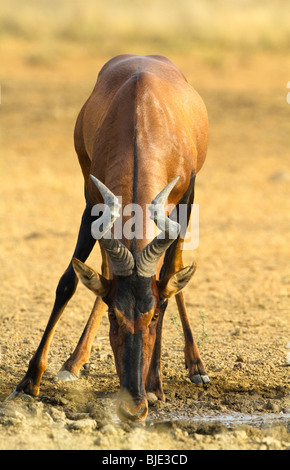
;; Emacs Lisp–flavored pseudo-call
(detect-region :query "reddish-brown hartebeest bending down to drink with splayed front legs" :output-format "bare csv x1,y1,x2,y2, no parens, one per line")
10,55,209,420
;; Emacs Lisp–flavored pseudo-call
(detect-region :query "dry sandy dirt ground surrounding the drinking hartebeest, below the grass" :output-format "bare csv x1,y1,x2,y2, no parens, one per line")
0,40,290,450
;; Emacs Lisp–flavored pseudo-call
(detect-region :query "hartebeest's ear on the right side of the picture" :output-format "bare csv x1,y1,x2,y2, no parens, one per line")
157,263,196,299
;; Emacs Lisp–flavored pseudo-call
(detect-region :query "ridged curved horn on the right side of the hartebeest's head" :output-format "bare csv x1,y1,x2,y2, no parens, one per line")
136,176,181,277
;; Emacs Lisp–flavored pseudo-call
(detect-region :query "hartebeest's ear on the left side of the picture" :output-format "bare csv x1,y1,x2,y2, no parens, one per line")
72,258,111,297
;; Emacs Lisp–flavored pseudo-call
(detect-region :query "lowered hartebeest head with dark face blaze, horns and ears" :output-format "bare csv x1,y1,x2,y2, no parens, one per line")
73,175,195,420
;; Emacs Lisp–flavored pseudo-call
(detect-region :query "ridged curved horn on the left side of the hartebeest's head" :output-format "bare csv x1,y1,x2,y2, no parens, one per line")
90,175,134,276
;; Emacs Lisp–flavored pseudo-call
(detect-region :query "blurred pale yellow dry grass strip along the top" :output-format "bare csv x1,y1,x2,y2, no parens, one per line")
0,0,290,52
